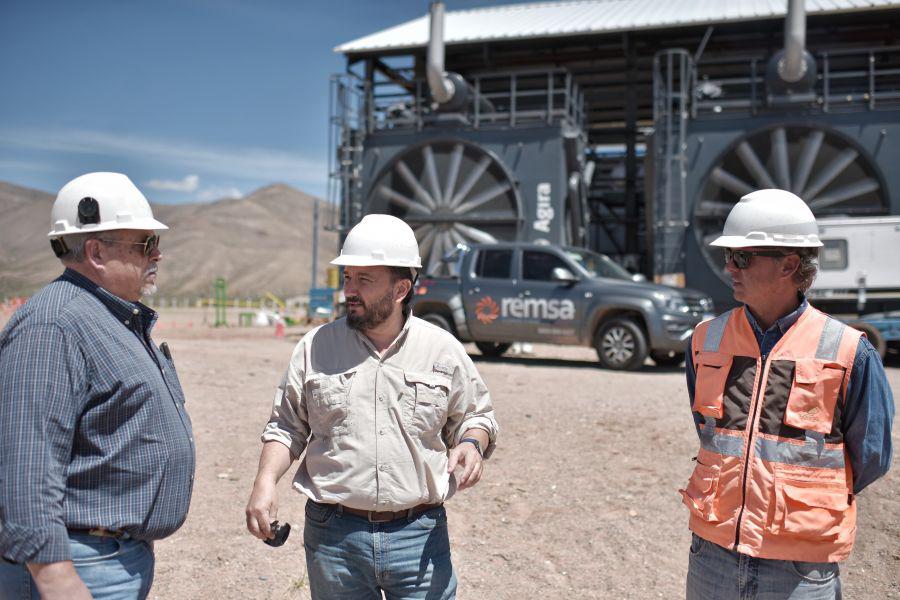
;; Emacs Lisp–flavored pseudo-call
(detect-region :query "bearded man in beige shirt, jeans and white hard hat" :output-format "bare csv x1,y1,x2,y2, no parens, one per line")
246,215,498,600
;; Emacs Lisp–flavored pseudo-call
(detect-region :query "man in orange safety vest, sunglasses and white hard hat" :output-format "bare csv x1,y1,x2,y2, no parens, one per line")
681,190,894,600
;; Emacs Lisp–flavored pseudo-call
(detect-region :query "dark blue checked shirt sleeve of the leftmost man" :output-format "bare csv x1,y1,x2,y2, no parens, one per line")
0,324,88,563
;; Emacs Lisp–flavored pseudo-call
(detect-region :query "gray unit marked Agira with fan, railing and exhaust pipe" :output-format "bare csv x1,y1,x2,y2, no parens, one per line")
332,2,591,275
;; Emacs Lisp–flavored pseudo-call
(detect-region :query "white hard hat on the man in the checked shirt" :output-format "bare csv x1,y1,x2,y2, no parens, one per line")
47,173,168,238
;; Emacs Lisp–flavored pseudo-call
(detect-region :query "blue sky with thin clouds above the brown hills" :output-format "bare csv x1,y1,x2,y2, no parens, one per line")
0,0,508,203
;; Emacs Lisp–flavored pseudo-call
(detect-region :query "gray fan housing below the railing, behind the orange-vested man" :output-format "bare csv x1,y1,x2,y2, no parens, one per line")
684,111,900,306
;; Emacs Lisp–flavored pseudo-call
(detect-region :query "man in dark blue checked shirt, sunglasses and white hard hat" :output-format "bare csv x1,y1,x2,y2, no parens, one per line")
0,173,194,600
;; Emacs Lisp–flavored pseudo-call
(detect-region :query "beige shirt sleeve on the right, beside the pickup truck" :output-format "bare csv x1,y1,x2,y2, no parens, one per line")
444,355,500,458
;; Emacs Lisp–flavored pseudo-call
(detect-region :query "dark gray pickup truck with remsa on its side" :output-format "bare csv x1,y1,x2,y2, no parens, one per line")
411,242,713,370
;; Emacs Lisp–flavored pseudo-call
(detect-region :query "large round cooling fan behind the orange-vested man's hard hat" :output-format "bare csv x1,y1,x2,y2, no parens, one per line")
693,124,889,283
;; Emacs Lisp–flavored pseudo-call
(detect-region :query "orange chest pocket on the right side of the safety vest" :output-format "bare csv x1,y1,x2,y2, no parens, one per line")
784,358,844,433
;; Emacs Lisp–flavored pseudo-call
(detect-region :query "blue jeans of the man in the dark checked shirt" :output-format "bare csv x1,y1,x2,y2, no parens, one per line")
0,532,155,600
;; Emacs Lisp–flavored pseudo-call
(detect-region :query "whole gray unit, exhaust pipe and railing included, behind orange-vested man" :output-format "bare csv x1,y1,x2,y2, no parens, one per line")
651,0,900,309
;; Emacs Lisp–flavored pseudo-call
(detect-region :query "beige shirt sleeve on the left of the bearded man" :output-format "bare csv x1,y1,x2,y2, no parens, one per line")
262,338,309,459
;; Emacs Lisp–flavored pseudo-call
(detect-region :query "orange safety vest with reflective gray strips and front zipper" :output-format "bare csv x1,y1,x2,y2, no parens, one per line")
680,306,861,562
